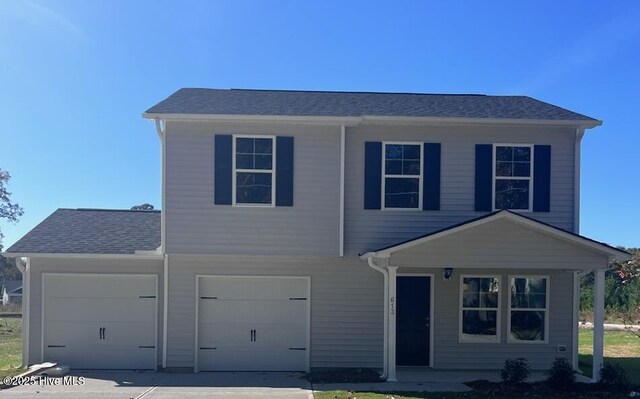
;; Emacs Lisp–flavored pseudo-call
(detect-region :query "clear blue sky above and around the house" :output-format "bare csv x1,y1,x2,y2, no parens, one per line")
0,0,640,247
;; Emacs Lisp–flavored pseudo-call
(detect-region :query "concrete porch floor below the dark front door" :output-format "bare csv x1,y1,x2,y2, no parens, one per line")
396,367,591,383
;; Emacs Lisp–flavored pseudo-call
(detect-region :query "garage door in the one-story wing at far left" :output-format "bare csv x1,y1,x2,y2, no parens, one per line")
43,274,157,369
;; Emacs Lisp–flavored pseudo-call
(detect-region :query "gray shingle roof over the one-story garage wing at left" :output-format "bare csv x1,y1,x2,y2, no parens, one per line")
7,209,160,254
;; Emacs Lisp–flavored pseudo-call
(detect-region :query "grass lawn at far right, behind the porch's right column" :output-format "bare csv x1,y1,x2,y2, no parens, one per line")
578,331,640,385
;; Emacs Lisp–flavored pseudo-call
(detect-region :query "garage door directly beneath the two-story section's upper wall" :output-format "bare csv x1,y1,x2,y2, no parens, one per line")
197,276,310,371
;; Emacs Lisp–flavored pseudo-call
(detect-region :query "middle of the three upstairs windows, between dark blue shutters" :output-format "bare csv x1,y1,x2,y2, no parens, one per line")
382,143,423,209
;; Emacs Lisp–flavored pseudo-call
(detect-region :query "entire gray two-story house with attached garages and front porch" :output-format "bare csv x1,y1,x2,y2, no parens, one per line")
7,89,629,380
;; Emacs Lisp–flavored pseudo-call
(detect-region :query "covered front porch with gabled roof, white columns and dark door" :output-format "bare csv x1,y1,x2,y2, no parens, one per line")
361,211,629,382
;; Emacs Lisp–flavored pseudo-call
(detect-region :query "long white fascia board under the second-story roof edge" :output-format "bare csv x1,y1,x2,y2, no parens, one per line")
142,112,602,129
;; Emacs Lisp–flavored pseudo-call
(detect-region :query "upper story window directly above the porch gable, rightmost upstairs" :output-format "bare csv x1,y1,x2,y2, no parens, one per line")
493,144,533,211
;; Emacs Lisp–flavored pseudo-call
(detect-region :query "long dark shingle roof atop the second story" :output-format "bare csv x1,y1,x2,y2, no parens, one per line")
146,88,596,122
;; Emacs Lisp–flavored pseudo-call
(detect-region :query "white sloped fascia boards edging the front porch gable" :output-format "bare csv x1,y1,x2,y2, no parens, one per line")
372,211,631,261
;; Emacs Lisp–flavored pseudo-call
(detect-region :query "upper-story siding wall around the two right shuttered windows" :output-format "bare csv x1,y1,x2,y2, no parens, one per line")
345,125,575,254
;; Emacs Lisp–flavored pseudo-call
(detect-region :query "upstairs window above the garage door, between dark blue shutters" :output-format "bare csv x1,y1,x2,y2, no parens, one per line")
233,135,275,206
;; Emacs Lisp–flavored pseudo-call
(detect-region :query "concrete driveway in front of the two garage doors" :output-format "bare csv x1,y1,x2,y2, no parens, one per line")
0,370,313,399
